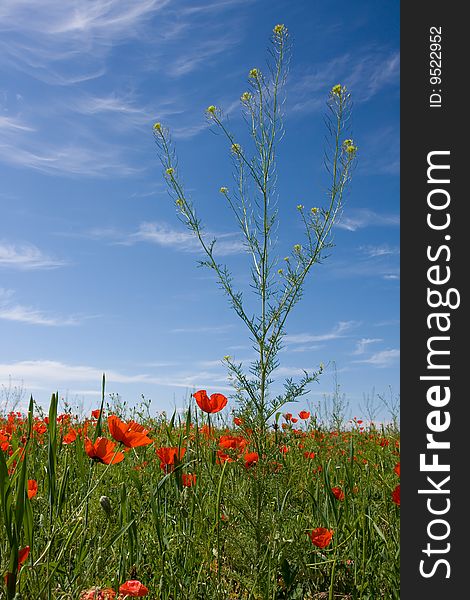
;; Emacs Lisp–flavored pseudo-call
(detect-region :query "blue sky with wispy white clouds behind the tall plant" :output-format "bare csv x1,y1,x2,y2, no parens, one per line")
0,0,400,418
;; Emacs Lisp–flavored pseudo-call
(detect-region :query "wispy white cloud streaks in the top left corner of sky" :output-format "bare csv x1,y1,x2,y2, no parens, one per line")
0,0,170,85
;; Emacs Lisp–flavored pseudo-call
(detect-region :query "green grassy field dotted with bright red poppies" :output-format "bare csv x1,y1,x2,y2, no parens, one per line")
0,390,400,600
